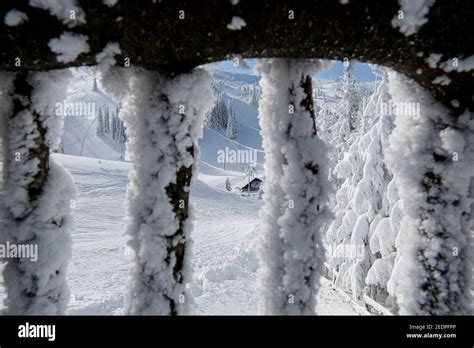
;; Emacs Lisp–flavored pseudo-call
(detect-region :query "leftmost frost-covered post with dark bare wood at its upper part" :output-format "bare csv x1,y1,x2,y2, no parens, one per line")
0,71,74,315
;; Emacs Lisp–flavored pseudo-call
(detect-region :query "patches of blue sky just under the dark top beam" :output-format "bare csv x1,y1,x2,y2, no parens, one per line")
219,59,375,82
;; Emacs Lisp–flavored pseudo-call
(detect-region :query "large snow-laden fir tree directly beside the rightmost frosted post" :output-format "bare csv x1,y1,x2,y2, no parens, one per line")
327,68,396,301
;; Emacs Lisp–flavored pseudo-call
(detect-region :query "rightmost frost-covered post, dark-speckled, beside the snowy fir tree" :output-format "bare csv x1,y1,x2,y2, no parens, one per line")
387,73,474,315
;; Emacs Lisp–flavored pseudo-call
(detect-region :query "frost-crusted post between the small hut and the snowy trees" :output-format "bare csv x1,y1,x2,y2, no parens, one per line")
255,59,329,314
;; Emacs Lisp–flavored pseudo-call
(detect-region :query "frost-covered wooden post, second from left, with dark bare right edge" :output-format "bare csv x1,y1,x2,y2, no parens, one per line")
116,69,214,315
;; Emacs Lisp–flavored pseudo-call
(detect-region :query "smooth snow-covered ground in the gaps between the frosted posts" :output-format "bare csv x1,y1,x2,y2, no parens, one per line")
0,155,358,315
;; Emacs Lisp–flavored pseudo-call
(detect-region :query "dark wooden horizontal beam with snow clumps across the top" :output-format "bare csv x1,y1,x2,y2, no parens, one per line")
0,0,474,113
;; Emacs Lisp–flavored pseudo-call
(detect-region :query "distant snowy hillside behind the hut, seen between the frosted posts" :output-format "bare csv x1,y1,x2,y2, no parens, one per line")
59,68,358,178
